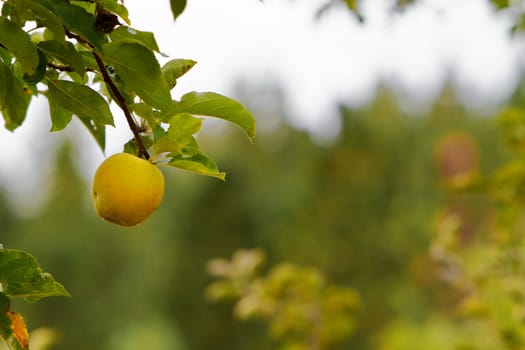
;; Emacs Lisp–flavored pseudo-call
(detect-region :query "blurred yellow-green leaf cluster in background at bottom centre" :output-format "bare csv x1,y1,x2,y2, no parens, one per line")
207,249,361,350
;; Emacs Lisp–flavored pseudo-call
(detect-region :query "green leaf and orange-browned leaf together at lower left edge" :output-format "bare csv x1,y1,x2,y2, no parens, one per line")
0,248,70,350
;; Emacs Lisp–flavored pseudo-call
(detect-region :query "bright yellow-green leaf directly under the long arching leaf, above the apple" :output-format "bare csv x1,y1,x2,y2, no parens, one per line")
154,113,202,154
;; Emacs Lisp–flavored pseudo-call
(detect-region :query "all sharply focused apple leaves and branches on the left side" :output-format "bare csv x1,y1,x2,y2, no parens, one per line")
0,0,255,350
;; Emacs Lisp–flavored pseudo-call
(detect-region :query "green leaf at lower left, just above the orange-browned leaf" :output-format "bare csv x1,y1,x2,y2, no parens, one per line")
0,248,70,302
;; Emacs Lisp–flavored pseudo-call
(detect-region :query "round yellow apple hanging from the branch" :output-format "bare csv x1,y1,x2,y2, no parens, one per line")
91,153,164,226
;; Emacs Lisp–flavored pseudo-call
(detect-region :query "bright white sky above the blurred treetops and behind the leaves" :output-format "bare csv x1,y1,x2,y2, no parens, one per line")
0,0,521,213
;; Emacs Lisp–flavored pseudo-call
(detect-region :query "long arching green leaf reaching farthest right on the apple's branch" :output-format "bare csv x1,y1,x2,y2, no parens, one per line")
171,92,256,139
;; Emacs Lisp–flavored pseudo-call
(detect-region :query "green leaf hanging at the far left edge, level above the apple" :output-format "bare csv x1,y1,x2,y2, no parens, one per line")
1,64,31,131
